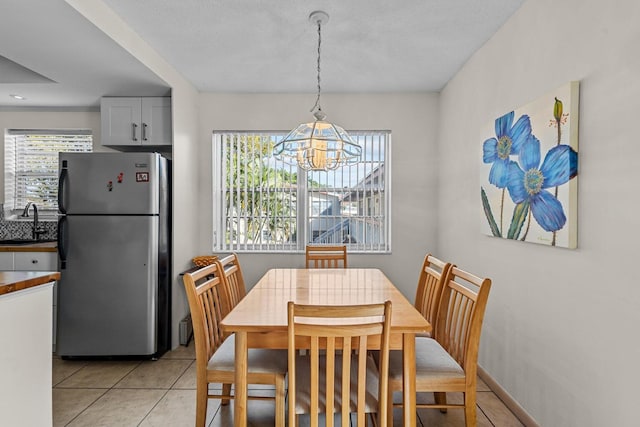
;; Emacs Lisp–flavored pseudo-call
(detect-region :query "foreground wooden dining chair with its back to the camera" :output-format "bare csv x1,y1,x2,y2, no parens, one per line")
287,301,391,427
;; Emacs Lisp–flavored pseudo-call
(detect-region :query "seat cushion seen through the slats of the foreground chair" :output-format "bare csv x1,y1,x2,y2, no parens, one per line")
296,355,378,414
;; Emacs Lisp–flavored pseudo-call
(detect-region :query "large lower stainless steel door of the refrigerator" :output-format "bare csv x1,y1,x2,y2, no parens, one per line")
57,215,159,356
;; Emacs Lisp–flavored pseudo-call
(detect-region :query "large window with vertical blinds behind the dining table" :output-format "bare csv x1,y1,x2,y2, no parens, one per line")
213,131,391,253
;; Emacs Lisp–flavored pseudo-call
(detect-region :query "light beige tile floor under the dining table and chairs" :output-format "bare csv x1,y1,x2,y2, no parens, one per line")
53,341,522,427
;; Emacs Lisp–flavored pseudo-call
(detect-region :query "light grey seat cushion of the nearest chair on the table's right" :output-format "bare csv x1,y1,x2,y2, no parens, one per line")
389,337,465,381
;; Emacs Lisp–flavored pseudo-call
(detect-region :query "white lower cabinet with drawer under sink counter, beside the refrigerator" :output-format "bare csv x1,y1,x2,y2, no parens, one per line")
0,252,58,352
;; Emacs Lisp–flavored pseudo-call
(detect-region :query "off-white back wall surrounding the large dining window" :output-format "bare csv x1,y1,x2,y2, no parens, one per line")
198,93,438,300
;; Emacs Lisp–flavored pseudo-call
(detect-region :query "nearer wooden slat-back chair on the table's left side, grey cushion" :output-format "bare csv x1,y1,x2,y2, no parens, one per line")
183,263,287,426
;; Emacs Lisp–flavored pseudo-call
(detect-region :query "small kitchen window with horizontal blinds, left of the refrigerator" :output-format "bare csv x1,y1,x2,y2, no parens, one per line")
4,129,93,213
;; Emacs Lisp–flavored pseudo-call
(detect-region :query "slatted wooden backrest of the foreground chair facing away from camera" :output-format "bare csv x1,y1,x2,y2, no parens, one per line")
287,301,391,426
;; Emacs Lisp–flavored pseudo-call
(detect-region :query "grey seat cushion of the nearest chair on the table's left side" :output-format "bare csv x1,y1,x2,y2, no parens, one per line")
207,335,287,374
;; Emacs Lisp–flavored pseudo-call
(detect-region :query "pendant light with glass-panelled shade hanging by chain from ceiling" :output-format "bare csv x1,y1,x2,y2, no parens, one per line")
274,11,362,171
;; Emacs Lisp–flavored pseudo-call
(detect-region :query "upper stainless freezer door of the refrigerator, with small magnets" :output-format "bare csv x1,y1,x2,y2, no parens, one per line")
58,153,165,215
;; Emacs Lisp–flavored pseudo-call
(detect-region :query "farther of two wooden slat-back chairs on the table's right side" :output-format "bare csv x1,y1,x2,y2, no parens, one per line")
414,254,452,337
